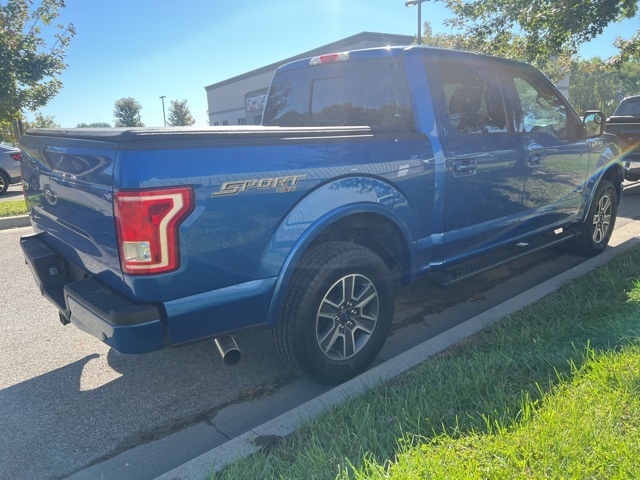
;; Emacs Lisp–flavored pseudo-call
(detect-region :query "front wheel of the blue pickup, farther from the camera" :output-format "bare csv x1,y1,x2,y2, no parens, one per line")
574,180,618,256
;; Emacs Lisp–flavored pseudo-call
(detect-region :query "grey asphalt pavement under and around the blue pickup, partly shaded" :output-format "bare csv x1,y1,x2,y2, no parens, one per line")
0,185,640,479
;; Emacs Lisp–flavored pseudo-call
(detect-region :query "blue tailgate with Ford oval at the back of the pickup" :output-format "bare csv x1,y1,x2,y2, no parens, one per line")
22,132,121,285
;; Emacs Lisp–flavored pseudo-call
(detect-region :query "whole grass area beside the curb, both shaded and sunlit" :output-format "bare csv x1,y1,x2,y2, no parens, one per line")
212,248,640,479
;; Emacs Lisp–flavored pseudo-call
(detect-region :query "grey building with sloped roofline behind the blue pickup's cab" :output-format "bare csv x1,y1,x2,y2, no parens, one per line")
205,32,414,126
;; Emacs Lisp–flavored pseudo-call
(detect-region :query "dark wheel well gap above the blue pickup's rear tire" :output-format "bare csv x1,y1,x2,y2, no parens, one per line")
310,213,410,276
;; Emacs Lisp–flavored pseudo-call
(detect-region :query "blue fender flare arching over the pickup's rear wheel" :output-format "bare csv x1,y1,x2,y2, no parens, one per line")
263,177,417,328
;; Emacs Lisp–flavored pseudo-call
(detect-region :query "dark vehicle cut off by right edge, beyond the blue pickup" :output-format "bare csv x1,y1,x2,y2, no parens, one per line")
607,95,640,182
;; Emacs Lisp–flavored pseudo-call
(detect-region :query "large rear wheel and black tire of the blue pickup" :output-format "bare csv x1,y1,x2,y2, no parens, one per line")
273,242,395,385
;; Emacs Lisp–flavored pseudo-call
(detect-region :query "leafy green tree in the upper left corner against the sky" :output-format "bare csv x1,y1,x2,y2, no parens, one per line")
0,0,75,123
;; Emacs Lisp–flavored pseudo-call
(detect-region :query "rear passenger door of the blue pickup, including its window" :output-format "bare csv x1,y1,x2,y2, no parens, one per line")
427,57,526,262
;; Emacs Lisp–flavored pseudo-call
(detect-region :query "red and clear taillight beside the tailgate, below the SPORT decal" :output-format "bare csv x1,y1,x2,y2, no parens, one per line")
114,187,194,275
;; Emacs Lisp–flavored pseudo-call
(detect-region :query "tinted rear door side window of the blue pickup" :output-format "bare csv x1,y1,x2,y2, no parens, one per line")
439,61,509,134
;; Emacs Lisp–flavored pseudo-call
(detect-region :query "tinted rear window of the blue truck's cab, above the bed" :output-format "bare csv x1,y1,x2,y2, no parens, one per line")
264,58,414,130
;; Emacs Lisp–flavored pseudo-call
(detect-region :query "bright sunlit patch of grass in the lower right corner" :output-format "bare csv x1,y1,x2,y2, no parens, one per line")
372,345,640,479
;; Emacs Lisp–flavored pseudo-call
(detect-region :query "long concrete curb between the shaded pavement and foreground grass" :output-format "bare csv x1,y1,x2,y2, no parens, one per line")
156,228,640,480
